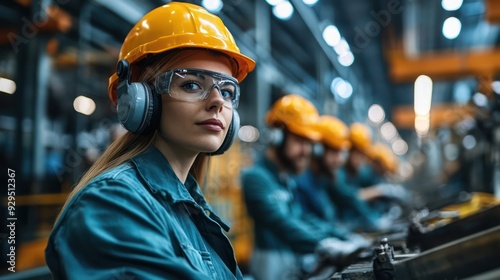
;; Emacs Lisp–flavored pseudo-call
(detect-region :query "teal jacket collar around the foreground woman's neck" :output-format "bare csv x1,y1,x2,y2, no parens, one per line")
132,146,229,231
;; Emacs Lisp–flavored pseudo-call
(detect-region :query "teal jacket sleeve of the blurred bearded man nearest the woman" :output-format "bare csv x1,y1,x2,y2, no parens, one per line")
241,170,326,253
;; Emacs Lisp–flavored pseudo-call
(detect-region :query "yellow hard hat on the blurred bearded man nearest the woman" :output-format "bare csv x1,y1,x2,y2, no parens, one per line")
265,94,321,141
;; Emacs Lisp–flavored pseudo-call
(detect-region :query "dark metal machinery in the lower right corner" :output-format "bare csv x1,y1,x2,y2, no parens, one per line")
330,193,500,280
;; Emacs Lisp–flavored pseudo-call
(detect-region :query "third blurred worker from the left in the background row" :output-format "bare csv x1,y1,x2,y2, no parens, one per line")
332,122,388,231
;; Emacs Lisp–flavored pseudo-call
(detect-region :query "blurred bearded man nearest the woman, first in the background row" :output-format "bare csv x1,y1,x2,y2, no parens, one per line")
241,94,362,280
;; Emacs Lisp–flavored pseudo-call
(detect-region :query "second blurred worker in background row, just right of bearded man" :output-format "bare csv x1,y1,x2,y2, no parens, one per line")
297,115,370,243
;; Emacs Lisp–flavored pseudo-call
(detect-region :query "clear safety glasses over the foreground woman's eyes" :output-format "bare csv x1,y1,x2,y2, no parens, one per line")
154,68,240,109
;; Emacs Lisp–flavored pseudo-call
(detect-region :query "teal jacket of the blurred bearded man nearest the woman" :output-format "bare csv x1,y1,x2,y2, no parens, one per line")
241,157,330,256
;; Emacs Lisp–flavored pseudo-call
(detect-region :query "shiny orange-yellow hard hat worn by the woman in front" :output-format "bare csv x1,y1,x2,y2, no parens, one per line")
108,2,255,102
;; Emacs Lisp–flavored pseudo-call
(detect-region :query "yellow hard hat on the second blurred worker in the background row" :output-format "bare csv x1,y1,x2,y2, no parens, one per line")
319,115,351,150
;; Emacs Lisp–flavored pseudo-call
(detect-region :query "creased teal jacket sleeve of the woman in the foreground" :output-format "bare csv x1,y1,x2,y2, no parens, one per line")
47,180,207,280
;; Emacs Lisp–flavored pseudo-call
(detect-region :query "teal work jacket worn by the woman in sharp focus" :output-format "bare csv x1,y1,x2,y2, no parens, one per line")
45,147,243,280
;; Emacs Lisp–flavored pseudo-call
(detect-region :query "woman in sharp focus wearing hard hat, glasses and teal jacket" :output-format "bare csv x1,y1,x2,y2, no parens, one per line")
46,2,254,279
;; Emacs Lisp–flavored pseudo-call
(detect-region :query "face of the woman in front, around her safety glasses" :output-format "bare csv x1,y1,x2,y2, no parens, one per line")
159,51,233,153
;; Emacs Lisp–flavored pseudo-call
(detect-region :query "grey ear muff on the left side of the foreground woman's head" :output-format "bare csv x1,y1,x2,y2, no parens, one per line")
116,59,161,134
